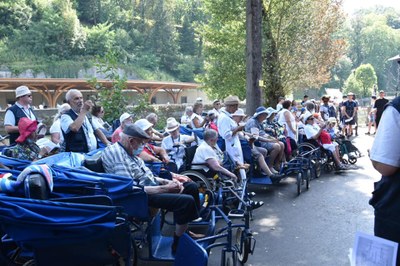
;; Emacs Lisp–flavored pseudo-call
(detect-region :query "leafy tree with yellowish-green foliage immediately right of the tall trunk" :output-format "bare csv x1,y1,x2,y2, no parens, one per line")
263,0,345,105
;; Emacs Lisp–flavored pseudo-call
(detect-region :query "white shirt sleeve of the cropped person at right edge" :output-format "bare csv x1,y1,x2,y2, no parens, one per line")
370,106,400,167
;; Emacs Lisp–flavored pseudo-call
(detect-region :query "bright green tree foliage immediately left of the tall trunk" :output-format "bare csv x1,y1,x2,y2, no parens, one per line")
198,0,246,99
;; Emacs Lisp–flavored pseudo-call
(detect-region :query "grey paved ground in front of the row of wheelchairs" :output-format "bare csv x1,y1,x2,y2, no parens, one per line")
140,125,379,266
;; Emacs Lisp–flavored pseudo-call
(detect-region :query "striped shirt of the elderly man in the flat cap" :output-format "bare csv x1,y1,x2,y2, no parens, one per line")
101,142,159,186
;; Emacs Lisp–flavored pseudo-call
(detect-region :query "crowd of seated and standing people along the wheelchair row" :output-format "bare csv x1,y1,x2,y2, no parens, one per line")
4,86,387,255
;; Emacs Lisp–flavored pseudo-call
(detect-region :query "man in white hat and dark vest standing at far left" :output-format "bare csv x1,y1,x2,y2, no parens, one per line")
4,86,37,145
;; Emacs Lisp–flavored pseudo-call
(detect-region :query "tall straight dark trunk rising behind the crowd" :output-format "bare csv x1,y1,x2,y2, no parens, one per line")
246,0,262,115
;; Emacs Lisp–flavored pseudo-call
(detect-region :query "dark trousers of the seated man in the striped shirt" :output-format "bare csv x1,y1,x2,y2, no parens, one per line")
148,182,200,225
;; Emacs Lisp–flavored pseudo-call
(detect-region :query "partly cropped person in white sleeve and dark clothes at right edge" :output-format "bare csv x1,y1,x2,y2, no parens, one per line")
369,96,400,265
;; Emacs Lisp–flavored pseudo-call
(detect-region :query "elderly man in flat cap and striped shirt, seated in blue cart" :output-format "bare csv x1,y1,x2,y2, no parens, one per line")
101,124,203,252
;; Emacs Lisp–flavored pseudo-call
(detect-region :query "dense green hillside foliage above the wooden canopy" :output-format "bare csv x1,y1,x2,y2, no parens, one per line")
0,0,203,81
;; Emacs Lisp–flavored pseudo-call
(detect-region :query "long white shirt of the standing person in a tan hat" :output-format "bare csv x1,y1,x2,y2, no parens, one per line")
217,110,244,164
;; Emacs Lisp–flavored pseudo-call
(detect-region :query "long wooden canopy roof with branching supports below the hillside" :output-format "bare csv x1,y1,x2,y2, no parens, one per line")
0,78,200,107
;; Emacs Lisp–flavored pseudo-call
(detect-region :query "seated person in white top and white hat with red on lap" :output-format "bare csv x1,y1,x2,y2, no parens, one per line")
303,113,347,170
